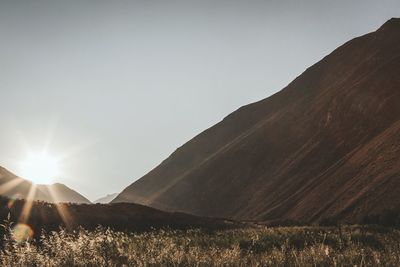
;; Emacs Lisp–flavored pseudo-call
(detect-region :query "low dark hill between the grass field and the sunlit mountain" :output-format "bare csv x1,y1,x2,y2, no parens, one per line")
0,196,236,238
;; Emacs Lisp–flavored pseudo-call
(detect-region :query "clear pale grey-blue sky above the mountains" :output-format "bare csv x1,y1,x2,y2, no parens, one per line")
0,0,400,200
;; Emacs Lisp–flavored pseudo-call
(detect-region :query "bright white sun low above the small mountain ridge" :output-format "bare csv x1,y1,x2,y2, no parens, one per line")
20,152,60,184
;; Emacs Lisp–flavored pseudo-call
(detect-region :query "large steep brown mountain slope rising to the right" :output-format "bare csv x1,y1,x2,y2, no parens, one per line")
112,18,400,223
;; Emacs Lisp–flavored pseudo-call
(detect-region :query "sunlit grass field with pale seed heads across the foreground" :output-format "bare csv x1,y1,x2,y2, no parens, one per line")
0,225,400,266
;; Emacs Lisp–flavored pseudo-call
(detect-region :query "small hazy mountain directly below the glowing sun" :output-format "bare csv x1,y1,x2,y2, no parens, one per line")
0,167,90,203
